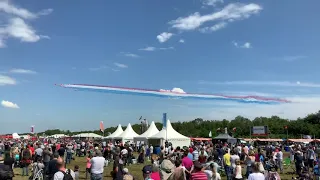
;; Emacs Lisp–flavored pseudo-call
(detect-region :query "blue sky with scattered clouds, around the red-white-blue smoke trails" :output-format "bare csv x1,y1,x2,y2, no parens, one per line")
0,0,320,133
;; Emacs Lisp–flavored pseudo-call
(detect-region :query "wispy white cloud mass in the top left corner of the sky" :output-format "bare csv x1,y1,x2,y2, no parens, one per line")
0,0,53,48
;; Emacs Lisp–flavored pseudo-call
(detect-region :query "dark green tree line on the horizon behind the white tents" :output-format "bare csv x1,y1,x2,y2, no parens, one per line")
34,111,320,138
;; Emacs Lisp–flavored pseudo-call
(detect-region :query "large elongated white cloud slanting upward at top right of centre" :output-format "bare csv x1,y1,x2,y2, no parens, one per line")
169,3,262,31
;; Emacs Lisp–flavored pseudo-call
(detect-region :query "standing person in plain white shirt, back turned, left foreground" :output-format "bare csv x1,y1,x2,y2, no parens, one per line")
90,151,105,180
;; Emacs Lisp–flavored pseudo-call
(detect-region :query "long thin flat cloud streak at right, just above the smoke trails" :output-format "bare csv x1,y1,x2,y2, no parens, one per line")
199,81,320,88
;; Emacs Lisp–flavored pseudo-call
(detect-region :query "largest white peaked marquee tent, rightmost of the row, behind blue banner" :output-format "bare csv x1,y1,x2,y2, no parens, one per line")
148,120,191,148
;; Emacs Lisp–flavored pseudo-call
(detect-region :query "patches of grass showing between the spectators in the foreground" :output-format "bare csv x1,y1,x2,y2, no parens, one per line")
14,154,293,180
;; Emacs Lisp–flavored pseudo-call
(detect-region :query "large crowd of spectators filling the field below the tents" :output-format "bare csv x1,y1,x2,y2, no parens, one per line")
0,140,319,180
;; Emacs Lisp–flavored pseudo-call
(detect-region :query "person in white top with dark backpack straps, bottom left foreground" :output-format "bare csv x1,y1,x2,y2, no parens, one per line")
53,158,76,180
